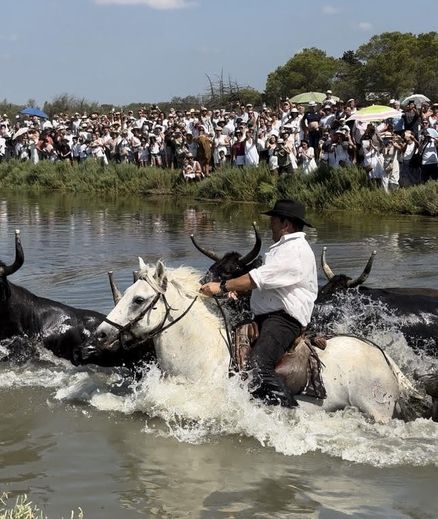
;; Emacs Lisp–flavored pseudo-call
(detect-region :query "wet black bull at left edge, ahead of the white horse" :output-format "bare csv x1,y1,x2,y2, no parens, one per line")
0,231,153,367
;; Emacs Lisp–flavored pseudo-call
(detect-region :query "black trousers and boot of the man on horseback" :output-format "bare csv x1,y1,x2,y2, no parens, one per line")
250,310,302,407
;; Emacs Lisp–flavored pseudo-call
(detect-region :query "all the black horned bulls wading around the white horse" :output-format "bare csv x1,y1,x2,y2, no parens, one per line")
0,228,438,419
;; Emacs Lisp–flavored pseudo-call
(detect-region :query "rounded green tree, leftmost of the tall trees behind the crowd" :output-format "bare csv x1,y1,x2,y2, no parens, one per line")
265,47,339,104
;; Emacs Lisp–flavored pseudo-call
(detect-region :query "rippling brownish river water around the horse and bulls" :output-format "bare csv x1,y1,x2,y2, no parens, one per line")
0,194,438,519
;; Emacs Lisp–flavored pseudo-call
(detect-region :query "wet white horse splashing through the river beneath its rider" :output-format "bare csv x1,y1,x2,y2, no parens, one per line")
96,258,415,423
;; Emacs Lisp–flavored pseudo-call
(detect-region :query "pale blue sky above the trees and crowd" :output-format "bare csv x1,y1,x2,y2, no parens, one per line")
0,0,438,106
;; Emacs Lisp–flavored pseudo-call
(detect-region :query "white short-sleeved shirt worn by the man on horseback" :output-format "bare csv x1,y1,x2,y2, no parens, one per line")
249,232,318,326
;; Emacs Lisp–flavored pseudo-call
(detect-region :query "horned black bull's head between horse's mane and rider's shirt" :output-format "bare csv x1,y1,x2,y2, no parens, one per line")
190,222,262,283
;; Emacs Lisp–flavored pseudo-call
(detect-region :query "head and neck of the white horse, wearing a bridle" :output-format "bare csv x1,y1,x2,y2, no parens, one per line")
96,258,229,380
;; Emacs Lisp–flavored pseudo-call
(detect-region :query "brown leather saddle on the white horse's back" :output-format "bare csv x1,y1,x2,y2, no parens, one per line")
232,322,327,400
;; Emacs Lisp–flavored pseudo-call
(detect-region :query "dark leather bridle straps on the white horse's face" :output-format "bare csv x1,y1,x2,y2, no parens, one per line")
103,276,198,349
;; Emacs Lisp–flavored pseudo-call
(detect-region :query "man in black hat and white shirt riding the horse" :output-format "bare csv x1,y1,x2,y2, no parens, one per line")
200,200,318,407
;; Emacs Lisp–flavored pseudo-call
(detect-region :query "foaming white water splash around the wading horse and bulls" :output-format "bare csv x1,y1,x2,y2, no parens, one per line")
0,297,438,467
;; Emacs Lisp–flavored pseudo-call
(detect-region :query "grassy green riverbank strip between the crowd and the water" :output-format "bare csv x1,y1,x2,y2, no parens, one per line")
0,161,438,216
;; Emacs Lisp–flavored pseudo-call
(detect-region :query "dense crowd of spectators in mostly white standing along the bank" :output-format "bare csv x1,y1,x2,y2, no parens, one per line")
0,90,438,191
